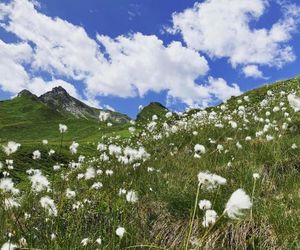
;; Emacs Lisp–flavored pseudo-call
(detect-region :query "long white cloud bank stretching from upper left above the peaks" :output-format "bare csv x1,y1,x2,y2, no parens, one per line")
0,0,241,105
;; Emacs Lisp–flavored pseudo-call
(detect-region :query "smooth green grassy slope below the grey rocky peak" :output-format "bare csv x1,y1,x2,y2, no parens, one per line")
0,96,127,144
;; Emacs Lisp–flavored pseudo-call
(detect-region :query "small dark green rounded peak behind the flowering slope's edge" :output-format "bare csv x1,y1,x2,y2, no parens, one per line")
136,102,169,122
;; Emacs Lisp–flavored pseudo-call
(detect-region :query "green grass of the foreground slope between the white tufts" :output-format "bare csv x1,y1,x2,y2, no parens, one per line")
0,78,300,249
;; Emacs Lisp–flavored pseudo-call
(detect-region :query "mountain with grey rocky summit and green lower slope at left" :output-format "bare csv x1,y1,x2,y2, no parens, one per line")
0,87,130,142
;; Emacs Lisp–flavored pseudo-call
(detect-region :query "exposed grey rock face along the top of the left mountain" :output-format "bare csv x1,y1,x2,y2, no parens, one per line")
18,86,130,124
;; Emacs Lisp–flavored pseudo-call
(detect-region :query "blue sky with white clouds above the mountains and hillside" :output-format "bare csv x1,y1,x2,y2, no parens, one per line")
0,0,300,118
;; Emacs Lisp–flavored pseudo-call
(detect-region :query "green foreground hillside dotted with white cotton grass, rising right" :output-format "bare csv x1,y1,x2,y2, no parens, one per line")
0,77,300,250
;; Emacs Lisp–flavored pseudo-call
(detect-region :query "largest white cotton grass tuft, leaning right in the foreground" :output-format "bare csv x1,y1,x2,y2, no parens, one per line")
224,189,252,219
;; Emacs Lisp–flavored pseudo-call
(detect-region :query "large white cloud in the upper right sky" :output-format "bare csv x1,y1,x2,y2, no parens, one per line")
173,0,300,67
